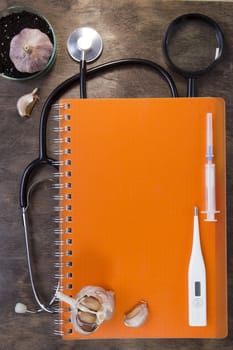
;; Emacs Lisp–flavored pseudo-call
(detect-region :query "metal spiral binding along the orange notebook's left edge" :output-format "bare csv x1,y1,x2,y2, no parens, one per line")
52,103,73,336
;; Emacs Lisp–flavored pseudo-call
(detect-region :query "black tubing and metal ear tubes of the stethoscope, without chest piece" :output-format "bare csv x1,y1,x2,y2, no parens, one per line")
20,58,178,313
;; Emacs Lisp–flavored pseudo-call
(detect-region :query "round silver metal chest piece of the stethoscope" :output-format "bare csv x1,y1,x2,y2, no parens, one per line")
67,27,103,62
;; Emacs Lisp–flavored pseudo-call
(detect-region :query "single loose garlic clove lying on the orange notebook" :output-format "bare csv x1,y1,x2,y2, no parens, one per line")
124,302,148,327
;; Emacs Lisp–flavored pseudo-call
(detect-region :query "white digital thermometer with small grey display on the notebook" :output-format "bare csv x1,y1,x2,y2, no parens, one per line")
188,207,207,327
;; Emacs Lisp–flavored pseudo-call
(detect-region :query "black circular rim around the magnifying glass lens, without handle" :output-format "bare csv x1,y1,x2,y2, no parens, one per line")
162,13,224,78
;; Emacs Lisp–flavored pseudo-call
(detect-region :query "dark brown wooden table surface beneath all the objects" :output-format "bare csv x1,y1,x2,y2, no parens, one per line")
0,0,233,350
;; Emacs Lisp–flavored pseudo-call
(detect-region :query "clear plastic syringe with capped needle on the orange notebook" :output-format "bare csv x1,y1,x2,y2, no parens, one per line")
202,113,219,221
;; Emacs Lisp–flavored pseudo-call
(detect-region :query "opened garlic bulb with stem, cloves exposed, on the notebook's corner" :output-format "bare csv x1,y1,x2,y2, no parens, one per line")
56,286,114,335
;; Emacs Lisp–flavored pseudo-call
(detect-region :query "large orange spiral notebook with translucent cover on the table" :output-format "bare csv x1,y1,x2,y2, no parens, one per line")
55,98,227,339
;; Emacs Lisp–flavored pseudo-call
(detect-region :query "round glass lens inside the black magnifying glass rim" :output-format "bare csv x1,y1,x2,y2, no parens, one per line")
167,18,220,73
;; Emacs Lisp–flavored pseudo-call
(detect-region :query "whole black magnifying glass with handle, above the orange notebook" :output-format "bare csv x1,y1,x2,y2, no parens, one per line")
163,13,224,97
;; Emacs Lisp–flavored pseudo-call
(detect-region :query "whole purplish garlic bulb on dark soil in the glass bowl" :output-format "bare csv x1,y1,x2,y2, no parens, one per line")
9,28,53,73
